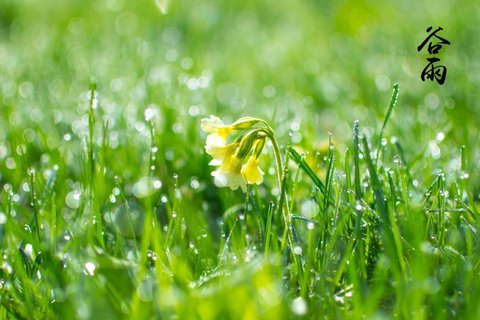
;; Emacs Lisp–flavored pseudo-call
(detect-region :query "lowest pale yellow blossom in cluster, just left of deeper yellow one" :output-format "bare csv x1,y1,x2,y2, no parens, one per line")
212,154,247,192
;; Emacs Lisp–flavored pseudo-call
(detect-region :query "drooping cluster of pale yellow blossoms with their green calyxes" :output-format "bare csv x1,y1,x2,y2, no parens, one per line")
201,115,271,192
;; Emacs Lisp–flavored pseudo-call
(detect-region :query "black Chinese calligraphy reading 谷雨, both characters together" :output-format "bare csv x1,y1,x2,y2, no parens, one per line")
417,27,451,85
